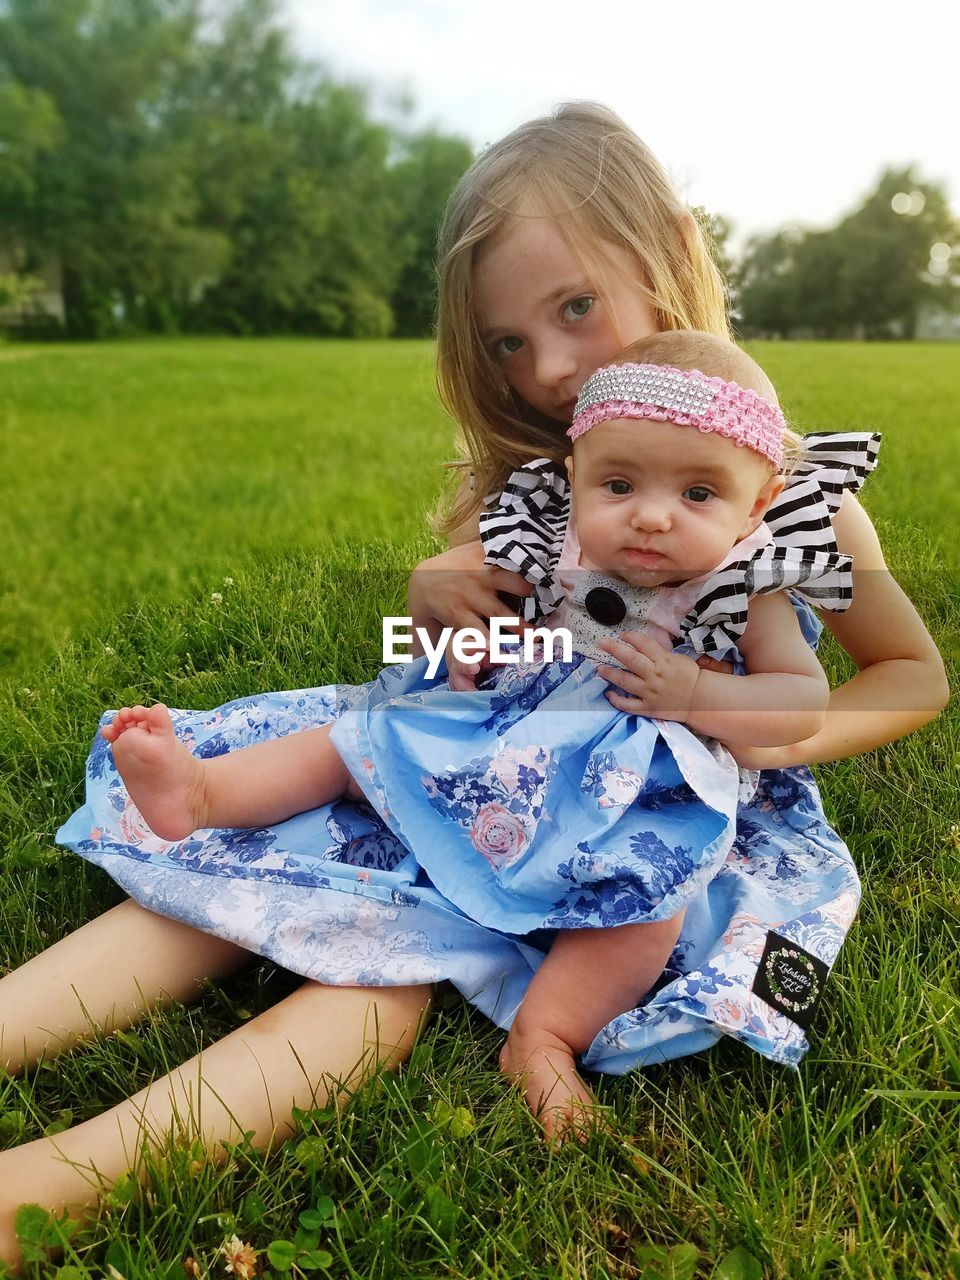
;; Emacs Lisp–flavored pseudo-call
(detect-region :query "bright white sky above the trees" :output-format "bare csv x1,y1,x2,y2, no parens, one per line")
282,0,960,241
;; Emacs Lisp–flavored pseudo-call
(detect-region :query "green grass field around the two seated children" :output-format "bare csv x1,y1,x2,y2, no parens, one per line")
0,340,960,1280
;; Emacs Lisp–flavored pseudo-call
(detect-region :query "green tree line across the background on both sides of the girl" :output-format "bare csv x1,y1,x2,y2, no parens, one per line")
0,0,960,338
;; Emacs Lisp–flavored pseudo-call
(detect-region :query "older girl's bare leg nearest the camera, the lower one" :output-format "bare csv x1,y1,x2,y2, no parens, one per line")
0,982,430,1263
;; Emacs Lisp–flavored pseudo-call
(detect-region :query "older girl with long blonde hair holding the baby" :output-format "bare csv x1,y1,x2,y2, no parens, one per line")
0,105,946,1258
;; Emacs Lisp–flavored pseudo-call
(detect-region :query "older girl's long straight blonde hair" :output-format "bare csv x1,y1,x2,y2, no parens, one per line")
436,102,730,534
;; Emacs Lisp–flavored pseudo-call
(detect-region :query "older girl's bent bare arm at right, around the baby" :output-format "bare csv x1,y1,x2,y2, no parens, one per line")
733,494,950,769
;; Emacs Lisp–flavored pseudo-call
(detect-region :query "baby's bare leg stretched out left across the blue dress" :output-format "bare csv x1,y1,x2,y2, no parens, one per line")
101,703,362,840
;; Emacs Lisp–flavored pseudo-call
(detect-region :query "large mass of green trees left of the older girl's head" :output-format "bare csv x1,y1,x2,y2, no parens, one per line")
0,0,470,337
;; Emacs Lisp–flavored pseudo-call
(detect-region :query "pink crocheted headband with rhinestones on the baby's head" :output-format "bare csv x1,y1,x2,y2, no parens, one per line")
567,365,786,471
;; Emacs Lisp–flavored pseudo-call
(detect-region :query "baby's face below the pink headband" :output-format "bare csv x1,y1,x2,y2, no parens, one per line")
567,419,782,586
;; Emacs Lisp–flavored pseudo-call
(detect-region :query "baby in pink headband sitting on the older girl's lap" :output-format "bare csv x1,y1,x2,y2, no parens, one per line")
84,332,844,1133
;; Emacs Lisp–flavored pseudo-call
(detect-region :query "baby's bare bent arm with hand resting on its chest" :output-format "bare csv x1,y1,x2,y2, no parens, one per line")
600,593,829,746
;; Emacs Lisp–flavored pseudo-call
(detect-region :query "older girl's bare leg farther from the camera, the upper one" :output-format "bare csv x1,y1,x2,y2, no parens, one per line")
0,901,251,1071
